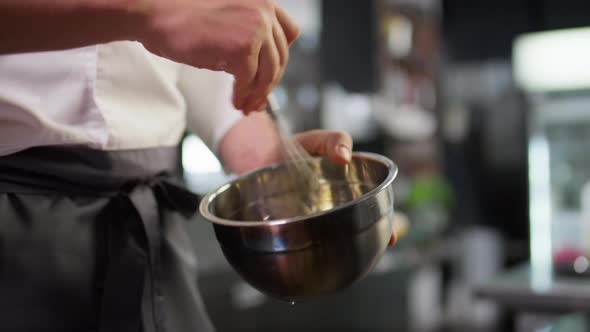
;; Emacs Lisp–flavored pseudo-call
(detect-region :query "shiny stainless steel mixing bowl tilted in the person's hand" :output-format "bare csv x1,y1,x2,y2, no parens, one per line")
200,153,397,301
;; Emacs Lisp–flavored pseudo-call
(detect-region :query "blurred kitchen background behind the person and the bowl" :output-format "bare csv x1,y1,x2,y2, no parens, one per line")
182,0,590,332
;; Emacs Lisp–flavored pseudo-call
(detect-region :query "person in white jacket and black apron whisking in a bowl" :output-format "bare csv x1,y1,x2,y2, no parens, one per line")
0,0,398,332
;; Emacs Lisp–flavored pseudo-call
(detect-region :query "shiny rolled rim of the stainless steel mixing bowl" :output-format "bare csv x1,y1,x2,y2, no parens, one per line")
199,152,398,227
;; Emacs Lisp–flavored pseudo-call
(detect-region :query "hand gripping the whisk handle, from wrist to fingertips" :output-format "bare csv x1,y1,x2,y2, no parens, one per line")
140,0,300,113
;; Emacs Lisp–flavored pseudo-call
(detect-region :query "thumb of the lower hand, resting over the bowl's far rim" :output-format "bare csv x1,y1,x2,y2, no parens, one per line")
295,130,353,164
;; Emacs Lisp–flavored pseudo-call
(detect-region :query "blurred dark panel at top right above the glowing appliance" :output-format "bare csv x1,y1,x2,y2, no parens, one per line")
443,0,590,61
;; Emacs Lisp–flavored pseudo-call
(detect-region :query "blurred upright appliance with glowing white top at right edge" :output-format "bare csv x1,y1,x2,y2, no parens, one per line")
513,28,590,280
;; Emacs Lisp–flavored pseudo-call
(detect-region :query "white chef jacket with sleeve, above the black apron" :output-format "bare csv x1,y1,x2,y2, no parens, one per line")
0,42,242,156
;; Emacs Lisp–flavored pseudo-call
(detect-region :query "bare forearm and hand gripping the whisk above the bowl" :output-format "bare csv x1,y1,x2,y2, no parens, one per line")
0,0,299,112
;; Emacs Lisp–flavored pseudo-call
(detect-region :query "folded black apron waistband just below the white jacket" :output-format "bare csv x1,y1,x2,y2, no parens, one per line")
0,146,178,196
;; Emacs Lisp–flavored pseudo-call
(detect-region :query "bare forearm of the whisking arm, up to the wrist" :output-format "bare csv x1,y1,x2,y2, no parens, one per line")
0,0,145,54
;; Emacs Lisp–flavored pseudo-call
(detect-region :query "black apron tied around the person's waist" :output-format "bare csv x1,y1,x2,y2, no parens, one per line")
0,147,213,332
